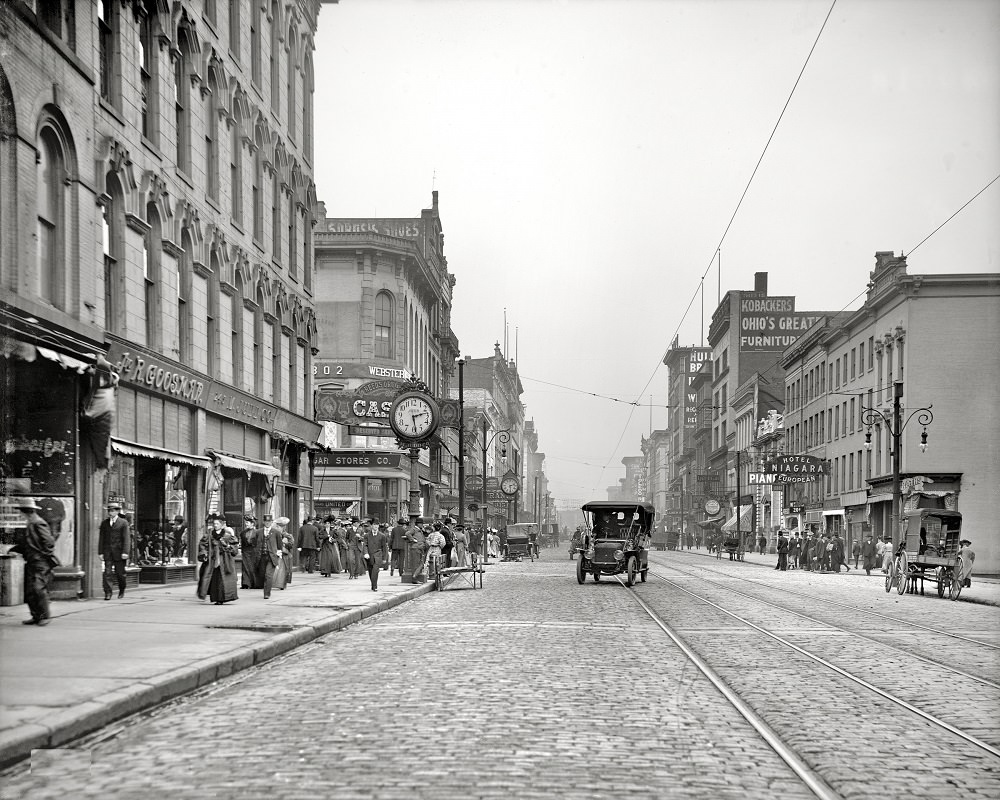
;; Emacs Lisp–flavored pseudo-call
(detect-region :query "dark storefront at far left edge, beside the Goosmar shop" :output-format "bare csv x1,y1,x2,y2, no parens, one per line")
0,306,111,599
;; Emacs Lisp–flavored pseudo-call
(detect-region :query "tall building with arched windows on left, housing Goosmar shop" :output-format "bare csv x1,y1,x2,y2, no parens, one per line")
0,0,319,596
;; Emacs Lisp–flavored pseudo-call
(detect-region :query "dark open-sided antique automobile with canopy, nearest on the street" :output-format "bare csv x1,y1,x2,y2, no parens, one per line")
576,500,656,586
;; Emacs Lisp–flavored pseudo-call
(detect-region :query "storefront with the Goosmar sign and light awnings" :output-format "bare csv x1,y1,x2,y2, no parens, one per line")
106,337,320,585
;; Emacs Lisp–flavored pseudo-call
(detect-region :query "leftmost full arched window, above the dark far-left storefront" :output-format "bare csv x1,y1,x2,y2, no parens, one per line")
35,125,67,310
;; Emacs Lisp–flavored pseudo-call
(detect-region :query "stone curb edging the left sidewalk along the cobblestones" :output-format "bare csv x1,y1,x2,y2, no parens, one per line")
0,583,434,769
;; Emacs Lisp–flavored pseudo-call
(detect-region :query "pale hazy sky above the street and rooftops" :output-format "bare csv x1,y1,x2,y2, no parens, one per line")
314,0,1000,508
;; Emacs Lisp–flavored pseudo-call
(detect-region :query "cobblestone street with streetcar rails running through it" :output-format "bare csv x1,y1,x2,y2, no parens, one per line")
0,550,1000,800
